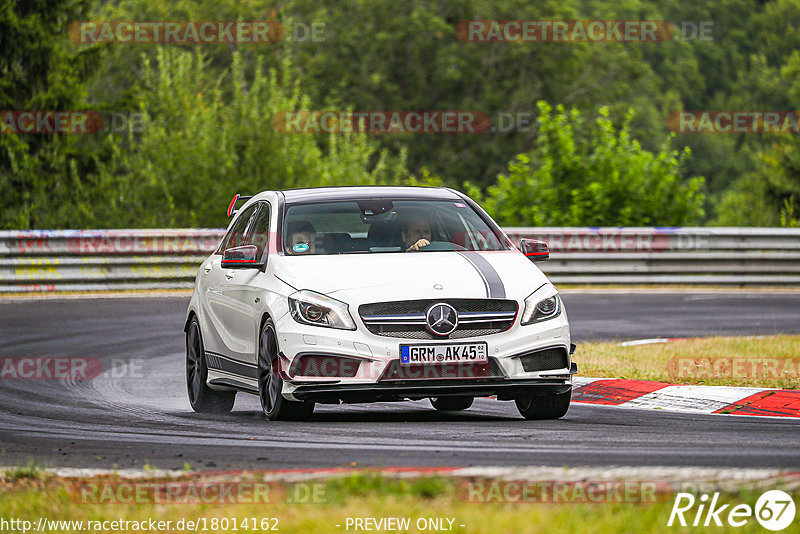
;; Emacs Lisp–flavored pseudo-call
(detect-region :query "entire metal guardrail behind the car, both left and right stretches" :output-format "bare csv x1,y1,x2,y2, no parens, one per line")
0,228,800,293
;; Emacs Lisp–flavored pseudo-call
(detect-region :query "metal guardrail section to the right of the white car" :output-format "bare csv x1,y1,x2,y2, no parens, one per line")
505,228,800,286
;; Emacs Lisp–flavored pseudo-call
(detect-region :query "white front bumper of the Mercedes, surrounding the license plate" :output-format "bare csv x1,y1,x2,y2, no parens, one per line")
276,306,576,403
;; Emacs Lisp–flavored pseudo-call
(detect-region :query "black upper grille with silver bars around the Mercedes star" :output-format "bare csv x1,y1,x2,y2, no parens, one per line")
358,299,518,339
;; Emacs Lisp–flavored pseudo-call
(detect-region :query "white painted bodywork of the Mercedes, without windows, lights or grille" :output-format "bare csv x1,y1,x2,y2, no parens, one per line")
187,188,575,410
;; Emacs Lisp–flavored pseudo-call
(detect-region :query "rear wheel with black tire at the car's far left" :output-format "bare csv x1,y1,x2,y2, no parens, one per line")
186,317,236,413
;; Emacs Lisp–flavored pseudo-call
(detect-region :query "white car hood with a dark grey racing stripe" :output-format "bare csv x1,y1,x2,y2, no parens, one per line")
275,251,547,303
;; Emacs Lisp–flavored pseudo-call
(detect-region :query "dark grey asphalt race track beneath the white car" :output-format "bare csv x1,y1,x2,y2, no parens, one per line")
0,292,800,469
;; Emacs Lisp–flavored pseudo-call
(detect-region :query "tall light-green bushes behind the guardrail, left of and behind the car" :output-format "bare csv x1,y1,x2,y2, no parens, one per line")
0,47,407,228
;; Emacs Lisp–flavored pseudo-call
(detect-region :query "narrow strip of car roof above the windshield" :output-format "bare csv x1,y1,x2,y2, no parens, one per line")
281,185,461,204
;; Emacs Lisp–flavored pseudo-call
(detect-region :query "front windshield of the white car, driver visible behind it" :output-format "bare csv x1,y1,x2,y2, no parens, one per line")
283,199,506,255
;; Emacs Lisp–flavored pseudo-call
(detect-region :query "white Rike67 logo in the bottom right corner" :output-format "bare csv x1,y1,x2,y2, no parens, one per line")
667,490,796,531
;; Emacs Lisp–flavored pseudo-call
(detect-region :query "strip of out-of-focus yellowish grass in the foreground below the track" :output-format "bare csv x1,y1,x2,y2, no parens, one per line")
0,474,798,534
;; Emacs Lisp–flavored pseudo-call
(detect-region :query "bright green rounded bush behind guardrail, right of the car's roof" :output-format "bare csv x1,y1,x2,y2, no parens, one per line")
467,102,703,226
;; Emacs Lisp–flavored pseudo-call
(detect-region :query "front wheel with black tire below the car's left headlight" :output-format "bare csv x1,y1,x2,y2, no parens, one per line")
258,318,314,421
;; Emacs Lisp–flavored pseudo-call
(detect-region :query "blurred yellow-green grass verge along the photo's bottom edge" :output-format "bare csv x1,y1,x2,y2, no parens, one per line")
0,474,797,534
